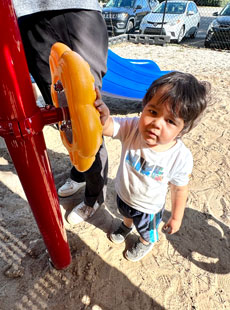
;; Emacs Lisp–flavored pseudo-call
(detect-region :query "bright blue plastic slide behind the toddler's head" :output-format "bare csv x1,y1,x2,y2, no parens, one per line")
102,49,171,100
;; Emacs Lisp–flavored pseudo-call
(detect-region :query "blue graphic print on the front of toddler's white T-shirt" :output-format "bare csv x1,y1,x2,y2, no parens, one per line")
125,151,164,181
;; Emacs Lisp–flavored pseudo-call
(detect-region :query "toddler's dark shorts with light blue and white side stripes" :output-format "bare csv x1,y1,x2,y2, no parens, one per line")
117,196,164,243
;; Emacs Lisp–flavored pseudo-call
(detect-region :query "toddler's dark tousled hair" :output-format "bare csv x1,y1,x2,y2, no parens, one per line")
143,71,210,135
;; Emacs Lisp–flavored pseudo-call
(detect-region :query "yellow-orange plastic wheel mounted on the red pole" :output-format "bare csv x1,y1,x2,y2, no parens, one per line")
50,42,102,171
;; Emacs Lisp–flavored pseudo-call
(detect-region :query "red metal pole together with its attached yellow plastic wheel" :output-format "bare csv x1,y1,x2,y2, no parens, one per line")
0,0,102,269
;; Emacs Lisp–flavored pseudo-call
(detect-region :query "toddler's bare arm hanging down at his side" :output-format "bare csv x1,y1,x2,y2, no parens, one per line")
163,184,188,234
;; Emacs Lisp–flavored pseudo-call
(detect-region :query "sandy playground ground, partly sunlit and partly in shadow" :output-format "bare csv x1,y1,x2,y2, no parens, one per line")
0,43,230,310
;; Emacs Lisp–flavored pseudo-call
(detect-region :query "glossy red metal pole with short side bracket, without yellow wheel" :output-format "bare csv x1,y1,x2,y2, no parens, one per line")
0,0,71,269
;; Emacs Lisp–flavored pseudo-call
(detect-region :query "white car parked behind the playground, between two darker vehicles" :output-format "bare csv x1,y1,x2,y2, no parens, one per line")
139,0,200,43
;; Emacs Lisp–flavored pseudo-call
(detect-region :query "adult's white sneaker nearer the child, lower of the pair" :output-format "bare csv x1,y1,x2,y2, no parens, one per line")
67,201,100,225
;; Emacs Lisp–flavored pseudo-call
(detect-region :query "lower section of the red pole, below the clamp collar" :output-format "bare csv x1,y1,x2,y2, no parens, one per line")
5,132,71,269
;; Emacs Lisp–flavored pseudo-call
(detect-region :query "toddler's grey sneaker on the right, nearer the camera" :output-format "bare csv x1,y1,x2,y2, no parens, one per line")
125,240,154,262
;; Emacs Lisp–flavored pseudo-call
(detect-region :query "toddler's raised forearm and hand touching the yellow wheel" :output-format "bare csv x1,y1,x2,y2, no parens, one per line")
94,88,113,137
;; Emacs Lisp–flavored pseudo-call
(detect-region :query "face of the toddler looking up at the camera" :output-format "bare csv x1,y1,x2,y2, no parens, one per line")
139,86,184,147
